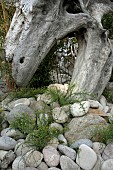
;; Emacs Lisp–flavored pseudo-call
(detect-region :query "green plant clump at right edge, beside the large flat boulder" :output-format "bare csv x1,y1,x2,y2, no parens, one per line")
92,117,113,144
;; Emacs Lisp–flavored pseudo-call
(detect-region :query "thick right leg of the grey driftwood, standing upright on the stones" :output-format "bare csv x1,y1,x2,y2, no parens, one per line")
72,28,113,97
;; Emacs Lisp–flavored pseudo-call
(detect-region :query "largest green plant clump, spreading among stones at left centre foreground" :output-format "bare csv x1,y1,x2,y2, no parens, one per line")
10,111,61,150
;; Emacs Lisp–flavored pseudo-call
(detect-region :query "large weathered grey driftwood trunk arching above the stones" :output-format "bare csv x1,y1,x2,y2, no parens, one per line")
5,0,113,97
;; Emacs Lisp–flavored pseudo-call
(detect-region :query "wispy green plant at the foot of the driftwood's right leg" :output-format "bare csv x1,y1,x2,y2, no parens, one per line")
47,84,87,106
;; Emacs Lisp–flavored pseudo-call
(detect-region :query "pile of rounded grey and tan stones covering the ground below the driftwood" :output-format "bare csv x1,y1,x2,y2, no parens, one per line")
0,84,113,170
